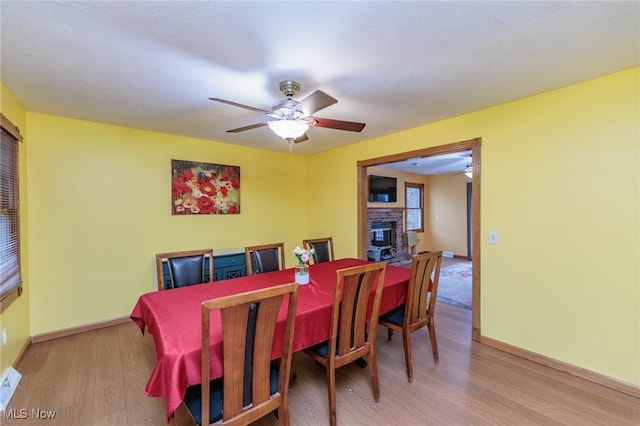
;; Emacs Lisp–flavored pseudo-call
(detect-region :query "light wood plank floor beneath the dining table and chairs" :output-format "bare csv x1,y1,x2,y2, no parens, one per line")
0,303,640,426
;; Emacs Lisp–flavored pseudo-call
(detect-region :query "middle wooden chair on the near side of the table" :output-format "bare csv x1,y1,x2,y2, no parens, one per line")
305,263,387,426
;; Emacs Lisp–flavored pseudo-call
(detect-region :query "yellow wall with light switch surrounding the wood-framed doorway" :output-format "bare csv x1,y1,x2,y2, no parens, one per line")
309,68,640,385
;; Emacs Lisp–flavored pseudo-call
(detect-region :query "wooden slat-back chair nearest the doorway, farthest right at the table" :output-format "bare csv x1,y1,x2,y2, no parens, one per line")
379,251,442,383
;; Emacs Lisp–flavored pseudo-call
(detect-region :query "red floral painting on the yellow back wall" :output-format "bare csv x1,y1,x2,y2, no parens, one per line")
171,160,240,215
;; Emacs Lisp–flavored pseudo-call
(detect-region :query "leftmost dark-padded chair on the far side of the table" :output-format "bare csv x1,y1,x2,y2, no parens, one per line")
156,249,214,290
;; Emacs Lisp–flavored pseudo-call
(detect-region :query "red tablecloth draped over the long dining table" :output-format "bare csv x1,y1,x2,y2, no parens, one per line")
131,259,410,417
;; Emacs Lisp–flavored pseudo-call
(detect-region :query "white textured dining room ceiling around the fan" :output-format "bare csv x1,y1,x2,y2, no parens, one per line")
0,0,640,160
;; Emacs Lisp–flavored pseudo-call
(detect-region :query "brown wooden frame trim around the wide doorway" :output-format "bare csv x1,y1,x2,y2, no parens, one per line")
357,138,482,342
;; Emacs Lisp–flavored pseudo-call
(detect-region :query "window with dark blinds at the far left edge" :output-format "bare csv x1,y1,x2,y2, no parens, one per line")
0,115,22,310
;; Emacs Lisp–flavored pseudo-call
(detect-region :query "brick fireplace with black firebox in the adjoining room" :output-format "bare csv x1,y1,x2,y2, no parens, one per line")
367,208,407,263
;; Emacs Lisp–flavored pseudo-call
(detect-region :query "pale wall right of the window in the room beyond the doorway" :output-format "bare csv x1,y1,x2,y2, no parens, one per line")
423,173,467,257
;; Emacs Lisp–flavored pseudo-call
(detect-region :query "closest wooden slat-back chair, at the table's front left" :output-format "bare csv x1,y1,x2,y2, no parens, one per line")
184,283,298,426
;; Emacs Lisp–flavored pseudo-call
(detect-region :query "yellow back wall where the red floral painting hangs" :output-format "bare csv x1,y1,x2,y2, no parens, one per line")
27,112,307,335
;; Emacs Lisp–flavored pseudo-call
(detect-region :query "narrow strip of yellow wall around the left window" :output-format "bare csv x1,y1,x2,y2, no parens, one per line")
0,84,31,373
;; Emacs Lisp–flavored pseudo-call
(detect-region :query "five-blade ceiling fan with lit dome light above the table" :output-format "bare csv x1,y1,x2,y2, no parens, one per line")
209,80,365,143
